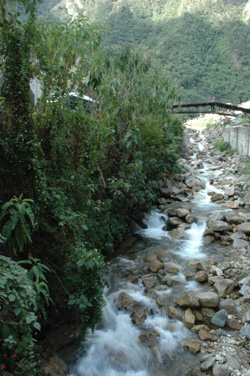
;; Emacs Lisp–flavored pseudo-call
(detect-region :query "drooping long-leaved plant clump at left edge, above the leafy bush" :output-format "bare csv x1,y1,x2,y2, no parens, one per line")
0,194,35,255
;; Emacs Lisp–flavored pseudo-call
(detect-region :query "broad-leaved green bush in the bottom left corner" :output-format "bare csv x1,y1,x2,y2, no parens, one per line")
0,256,50,375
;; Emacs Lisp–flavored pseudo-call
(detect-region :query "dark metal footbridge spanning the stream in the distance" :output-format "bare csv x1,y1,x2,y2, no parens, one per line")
172,100,250,116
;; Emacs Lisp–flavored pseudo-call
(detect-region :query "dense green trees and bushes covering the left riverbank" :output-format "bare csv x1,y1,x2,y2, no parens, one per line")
0,0,182,375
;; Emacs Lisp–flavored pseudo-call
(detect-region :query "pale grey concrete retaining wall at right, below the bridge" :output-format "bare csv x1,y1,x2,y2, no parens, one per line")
223,124,250,156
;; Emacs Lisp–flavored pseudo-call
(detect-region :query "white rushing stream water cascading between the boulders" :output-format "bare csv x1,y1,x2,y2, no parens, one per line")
69,157,228,376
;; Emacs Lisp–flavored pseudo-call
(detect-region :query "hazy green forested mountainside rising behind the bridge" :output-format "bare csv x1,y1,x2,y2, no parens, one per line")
37,0,250,101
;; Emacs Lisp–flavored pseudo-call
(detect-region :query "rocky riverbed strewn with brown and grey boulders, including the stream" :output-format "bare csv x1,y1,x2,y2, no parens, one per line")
37,128,250,376
